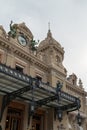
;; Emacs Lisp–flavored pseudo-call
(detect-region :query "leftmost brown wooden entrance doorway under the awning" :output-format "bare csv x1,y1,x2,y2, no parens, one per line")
5,102,25,130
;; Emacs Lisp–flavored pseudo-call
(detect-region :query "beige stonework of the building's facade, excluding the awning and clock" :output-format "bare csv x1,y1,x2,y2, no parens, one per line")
0,23,87,130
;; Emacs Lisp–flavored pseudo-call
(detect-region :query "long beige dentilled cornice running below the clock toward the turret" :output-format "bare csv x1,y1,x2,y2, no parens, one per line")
0,36,49,71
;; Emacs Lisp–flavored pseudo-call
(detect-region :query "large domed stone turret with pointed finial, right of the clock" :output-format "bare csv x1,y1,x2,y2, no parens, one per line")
37,29,66,75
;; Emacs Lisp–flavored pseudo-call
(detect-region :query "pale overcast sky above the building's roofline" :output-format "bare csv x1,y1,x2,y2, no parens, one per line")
0,0,87,91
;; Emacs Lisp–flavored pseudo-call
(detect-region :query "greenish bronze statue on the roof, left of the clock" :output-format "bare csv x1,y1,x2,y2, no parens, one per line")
8,21,17,38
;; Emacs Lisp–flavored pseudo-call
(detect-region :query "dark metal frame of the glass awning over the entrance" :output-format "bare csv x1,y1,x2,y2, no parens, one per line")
0,63,81,122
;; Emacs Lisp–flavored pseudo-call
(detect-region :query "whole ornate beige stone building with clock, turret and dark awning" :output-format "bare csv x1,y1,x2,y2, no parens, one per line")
0,21,87,130
